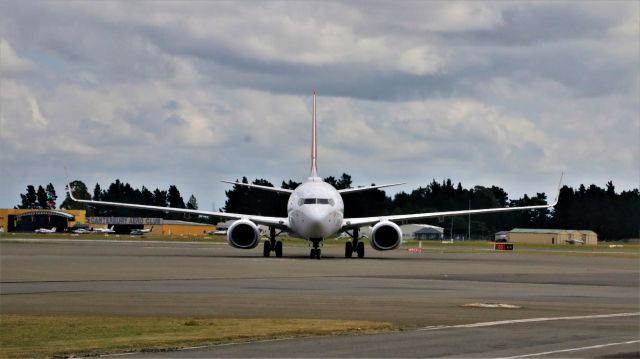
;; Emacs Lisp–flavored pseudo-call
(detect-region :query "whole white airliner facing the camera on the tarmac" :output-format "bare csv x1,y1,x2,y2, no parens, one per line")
67,92,562,259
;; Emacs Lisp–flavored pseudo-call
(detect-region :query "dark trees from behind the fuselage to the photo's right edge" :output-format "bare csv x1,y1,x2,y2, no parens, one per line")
223,173,640,240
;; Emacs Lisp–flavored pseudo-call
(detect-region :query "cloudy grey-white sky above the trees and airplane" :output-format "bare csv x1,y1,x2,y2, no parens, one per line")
0,1,640,209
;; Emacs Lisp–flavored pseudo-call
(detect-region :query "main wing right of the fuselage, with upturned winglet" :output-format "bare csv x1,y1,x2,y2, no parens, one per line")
342,175,562,230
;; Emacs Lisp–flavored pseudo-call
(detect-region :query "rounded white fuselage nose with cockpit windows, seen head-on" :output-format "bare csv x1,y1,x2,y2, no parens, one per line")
287,177,344,239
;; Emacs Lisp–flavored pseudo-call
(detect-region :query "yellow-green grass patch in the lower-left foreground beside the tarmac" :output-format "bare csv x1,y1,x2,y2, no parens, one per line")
0,315,397,358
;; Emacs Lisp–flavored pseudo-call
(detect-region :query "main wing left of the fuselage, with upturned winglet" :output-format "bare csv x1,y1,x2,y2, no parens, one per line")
68,184,289,230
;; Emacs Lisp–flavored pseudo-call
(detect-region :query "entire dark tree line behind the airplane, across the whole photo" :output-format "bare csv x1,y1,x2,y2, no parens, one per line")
16,173,640,240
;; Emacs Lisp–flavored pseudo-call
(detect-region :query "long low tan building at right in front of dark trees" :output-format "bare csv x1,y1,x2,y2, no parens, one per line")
496,228,598,245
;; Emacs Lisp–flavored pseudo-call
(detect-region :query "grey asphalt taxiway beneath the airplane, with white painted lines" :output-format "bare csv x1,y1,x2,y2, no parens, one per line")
0,239,640,357
